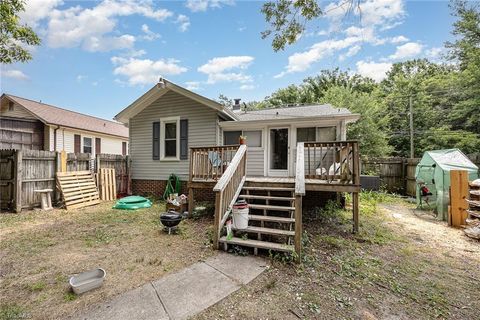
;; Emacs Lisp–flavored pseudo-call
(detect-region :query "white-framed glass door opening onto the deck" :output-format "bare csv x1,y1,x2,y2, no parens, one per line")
268,128,290,177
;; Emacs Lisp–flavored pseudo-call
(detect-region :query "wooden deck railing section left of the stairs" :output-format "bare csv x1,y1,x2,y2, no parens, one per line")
190,145,239,181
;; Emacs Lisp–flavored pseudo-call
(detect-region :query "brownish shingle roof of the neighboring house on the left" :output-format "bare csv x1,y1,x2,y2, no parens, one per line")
1,94,128,138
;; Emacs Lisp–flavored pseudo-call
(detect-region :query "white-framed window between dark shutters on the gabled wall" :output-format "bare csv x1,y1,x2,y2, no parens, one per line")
160,117,180,160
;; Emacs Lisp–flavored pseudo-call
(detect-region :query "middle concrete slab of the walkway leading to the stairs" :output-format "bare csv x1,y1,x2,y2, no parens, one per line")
152,262,240,320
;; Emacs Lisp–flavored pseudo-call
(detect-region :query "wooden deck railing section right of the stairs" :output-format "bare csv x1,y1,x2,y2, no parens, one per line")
304,141,360,185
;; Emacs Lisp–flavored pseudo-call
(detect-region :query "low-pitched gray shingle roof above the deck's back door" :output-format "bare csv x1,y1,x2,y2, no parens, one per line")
235,104,352,121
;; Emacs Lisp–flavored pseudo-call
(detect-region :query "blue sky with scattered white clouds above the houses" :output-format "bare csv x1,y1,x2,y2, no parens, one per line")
1,0,454,119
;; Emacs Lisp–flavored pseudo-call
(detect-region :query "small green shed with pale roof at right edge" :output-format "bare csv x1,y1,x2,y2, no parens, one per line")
415,149,479,220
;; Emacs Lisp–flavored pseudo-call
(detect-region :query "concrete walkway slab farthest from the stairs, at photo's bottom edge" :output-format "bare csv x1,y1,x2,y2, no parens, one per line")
72,283,169,320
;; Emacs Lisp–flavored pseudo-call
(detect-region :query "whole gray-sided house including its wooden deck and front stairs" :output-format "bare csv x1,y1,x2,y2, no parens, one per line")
115,79,360,255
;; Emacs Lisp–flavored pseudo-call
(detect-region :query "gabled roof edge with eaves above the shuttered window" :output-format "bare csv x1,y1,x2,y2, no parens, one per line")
114,78,238,123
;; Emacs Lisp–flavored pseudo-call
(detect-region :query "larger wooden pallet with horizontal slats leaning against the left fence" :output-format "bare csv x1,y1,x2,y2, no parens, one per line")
57,171,100,210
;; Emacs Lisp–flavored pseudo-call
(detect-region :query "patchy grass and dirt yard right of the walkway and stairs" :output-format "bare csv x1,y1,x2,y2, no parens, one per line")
195,193,480,319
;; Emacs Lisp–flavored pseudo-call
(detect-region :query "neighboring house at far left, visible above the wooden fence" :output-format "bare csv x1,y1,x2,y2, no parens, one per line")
0,94,129,158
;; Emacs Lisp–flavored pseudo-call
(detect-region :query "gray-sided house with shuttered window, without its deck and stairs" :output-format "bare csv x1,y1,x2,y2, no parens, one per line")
115,80,359,188
